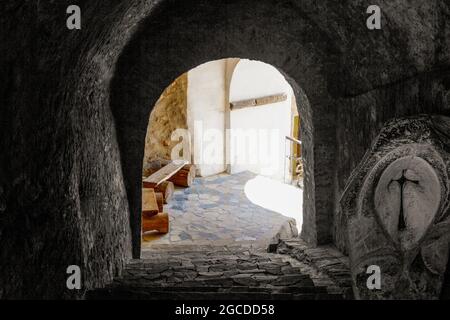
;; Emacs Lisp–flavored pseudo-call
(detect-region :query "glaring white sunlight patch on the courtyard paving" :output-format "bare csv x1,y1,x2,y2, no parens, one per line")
244,176,303,232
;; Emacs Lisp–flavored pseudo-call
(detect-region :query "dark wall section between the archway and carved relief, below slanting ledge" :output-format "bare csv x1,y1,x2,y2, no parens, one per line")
334,68,450,252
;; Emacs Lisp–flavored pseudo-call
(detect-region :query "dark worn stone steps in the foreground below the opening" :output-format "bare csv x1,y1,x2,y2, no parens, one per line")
86,246,344,300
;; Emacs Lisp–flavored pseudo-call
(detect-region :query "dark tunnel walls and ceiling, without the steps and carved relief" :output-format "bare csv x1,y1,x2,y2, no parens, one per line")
0,0,450,299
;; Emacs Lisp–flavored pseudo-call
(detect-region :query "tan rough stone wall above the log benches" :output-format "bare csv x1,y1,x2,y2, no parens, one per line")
144,73,188,168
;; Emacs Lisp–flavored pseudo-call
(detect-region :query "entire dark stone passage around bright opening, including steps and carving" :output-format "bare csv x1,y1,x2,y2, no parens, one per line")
0,0,450,300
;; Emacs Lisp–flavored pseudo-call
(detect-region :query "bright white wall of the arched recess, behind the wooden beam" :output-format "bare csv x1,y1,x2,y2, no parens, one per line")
228,60,293,180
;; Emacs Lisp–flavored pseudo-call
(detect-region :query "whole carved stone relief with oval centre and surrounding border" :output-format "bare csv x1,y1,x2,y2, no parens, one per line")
341,116,450,299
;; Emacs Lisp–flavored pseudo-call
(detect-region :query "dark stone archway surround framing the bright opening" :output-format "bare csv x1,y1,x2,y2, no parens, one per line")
110,1,337,257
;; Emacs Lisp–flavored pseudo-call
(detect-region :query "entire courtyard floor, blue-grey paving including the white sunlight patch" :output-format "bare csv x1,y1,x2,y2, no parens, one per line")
143,171,302,248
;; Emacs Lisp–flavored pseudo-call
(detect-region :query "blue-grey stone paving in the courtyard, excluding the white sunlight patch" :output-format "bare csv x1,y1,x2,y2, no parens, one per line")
143,172,298,247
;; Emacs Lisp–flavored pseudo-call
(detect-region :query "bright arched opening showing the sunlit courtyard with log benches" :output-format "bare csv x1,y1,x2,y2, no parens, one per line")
142,58,303,249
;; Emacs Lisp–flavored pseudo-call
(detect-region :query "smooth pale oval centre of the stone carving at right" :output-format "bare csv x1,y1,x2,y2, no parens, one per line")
374,156,441,250
